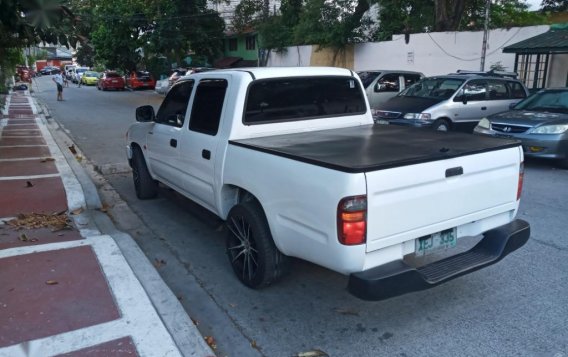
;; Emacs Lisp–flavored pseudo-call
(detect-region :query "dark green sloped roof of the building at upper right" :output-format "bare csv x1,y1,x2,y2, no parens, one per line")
503,24,568,54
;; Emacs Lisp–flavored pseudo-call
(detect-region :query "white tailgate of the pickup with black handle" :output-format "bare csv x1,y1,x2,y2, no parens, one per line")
366,147,521,251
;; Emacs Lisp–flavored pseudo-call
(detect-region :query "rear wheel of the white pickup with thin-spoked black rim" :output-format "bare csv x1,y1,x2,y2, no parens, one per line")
226,201,289,289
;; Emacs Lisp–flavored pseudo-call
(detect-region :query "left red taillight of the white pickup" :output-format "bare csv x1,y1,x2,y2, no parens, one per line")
337,196,367,245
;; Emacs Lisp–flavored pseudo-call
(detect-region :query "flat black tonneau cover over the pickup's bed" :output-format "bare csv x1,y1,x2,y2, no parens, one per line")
229,124,521,173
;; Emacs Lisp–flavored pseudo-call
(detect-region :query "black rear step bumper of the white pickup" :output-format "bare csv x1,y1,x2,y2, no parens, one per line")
348,219,530,300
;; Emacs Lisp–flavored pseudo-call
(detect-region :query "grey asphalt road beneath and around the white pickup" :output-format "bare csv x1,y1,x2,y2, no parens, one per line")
34,77,568,357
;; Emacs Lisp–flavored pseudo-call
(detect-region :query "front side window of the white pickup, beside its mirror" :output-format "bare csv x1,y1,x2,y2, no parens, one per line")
156,80,193,128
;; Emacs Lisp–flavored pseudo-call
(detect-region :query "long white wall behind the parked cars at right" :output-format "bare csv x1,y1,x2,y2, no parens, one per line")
354,26,549,76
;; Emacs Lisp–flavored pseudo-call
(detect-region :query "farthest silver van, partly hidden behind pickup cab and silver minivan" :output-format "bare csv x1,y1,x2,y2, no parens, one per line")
357,69,424,108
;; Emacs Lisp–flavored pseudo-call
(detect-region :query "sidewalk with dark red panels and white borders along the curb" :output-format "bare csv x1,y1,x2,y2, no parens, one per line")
0,87,214,357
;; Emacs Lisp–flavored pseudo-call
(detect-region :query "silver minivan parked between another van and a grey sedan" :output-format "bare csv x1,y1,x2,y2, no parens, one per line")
373,72,528,131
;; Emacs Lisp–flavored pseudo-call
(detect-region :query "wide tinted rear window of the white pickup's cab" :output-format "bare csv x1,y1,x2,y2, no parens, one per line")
243,77,367,125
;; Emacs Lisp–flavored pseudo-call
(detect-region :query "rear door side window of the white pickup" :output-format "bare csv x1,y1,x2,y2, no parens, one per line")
189,79,227,136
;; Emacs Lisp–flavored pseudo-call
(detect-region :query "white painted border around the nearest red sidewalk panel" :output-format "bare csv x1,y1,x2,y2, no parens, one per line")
0,235,181,357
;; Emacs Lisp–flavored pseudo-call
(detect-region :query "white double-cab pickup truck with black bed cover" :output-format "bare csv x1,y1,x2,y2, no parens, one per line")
127,67,530,300
